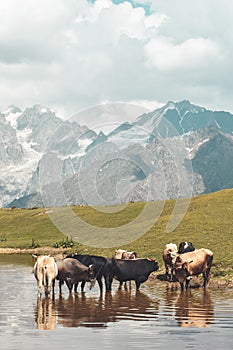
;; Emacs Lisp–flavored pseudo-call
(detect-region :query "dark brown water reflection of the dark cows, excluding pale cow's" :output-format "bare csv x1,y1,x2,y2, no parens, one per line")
55,291,158,327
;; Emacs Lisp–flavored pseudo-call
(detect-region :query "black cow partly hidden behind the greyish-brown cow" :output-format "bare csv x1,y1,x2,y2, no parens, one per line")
66,253,107,293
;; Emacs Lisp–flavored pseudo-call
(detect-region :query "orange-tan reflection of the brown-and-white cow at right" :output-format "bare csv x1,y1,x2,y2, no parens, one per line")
175,290,214,328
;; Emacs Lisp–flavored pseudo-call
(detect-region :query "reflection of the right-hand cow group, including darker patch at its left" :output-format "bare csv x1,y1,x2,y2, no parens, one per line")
164,289,214,328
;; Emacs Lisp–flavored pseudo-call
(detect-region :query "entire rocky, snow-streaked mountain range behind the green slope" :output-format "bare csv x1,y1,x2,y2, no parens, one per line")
0,100,233,207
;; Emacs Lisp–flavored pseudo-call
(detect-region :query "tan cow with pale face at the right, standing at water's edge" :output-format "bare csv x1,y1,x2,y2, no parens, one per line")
174,248,213,290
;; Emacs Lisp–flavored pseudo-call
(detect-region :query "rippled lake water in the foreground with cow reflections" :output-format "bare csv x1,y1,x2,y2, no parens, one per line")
0,255,233,350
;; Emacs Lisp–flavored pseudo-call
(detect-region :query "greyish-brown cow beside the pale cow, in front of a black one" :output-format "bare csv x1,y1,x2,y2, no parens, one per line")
56,258,95,294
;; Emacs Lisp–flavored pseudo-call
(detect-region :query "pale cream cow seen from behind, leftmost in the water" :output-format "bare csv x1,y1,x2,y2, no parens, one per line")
33,255,58,296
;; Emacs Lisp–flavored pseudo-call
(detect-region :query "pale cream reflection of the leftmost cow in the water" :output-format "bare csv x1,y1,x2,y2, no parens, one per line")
35,297,57,331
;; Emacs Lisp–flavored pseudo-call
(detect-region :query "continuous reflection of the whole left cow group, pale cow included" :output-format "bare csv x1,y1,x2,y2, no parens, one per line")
35,291,159,330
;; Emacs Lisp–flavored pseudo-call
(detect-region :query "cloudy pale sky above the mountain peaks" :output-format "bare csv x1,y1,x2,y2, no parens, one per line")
0,0,233,122
